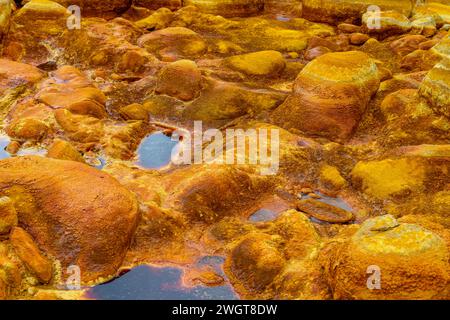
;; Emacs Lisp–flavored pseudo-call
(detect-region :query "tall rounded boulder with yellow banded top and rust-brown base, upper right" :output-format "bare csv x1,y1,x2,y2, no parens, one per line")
273,51,379,140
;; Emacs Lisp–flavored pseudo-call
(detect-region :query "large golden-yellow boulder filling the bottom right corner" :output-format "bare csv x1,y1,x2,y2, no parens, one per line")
322,216,449,299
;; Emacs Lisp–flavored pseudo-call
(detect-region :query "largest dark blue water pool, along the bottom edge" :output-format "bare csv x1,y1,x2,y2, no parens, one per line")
88,266,237,300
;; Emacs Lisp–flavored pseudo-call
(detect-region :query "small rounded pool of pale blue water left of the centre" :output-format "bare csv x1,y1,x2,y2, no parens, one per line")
137,132,178,169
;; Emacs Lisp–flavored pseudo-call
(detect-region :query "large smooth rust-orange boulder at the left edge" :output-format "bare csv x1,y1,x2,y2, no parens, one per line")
0,157,137,282
